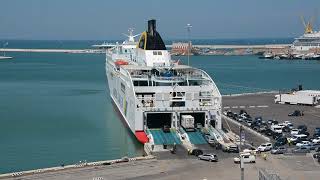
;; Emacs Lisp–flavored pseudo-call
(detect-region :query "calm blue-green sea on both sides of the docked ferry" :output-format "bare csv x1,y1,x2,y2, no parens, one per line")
0,41,320,173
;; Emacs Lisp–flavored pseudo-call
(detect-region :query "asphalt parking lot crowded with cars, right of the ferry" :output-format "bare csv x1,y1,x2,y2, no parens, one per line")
223,93,320,152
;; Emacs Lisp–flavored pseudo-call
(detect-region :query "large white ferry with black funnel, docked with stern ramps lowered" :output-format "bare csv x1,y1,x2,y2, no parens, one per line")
106,20,221,148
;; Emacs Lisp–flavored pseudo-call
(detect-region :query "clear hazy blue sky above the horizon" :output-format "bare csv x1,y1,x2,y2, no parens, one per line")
0,0,320,40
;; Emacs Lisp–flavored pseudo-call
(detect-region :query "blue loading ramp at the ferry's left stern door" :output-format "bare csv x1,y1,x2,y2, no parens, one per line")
147,129,181,145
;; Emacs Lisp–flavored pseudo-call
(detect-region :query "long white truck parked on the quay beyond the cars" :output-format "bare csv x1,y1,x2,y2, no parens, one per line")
274,90,320,106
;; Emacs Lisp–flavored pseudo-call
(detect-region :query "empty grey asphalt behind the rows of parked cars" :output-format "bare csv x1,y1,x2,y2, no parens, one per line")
222,93,320,132
